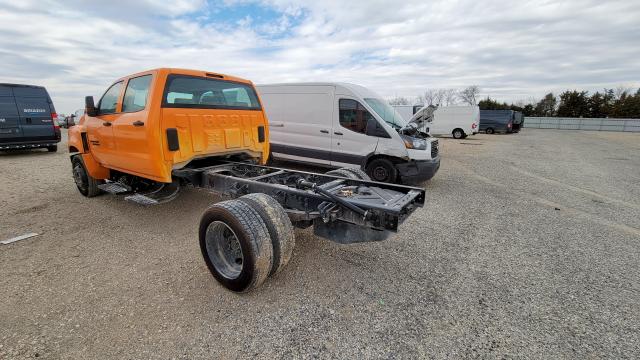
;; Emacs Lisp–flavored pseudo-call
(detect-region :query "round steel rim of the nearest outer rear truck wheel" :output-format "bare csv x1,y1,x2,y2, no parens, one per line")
205,221,244,280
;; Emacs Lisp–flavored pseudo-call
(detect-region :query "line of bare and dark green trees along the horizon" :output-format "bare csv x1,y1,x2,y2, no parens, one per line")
389,85,640,119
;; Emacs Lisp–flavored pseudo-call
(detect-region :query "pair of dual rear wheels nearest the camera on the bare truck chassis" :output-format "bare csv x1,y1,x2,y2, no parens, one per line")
199,193,295,292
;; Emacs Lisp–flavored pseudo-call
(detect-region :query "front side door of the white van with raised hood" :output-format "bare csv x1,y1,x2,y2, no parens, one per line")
331,97,378,166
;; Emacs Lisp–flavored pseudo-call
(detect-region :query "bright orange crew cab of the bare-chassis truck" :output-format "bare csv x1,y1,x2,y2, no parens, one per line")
69,68,269,183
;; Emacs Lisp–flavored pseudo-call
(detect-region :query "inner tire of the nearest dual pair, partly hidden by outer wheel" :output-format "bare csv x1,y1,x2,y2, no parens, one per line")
238,193,296,276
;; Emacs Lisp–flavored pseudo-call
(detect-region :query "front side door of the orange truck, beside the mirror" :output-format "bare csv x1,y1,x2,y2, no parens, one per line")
84,81,123,166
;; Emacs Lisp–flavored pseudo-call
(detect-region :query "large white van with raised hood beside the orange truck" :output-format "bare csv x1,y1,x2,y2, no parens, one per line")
257,83,440,183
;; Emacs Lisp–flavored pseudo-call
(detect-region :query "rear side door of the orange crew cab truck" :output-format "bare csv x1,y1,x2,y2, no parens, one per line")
112,74,158,175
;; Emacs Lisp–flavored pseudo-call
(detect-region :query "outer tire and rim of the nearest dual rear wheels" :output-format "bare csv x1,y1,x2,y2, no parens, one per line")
198,200,273,292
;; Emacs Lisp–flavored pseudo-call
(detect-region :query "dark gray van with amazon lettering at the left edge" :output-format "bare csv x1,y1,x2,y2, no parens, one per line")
0,84,60,152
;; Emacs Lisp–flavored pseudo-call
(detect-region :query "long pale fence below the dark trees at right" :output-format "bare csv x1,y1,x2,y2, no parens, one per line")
524,117,640,132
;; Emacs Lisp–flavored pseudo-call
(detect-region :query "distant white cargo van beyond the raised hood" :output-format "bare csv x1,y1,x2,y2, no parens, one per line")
410,106,480,139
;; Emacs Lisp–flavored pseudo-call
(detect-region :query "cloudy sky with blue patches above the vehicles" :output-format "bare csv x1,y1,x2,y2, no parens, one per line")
0,0,640,113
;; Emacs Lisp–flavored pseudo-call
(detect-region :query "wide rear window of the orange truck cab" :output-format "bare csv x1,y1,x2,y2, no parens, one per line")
162,75,261,110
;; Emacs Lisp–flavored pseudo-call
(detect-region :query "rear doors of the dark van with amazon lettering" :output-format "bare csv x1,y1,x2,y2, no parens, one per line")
13,86,56,141
